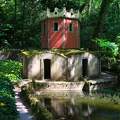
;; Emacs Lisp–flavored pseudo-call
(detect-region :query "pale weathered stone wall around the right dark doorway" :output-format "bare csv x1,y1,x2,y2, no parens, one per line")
68,52,100,81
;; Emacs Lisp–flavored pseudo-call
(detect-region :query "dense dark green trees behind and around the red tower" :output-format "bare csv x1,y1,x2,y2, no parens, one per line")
0,0,120,52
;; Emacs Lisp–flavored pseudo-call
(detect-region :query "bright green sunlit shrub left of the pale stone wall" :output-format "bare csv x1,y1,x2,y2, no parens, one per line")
0,60,22,82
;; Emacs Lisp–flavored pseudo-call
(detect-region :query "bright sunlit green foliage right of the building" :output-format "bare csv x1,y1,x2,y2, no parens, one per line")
94,38,120,71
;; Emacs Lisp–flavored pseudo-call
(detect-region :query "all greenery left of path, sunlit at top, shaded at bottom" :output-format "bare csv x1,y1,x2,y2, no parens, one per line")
0,60,22,120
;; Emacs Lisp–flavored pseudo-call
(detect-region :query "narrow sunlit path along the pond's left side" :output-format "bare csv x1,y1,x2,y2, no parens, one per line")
14,88,33,120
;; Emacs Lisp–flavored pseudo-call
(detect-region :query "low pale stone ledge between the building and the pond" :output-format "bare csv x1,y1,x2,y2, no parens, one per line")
19,73,117,92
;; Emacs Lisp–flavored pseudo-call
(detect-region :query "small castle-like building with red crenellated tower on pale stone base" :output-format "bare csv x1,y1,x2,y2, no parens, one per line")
22,8,114,90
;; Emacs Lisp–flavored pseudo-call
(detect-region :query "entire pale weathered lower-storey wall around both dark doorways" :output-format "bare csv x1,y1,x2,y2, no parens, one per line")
23,51,100,81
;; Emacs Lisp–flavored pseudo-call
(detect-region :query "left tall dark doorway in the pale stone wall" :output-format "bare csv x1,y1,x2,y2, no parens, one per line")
44,59,51,79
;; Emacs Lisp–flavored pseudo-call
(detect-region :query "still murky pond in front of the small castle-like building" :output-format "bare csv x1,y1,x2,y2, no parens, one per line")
33,92,120,120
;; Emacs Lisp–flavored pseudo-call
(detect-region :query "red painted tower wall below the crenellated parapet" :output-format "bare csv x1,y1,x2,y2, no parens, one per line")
41,18,80,48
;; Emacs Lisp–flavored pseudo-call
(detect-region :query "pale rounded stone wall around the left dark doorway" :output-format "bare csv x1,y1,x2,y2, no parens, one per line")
23,53,67,80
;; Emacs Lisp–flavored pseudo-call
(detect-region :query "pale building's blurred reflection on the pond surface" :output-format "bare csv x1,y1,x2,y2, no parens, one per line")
39,97,93,120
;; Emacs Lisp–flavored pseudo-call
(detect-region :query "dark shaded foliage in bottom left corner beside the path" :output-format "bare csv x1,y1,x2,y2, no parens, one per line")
0,74,18,120
